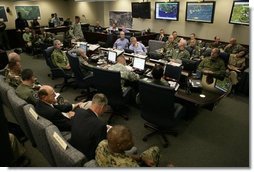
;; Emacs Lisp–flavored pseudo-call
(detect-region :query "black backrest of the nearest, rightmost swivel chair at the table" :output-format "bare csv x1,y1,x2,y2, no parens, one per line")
139,80,175,125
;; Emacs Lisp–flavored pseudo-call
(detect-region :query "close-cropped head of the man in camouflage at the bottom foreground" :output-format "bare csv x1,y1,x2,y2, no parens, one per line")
107,125,134,153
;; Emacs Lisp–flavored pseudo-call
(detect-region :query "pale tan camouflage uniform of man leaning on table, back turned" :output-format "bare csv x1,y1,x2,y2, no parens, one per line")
108,63,139,92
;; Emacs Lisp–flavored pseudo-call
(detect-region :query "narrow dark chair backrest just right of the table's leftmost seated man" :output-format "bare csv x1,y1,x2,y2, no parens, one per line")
67,52,84,81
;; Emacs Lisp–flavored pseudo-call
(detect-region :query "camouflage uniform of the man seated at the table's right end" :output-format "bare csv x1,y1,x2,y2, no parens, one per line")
198,57,226,77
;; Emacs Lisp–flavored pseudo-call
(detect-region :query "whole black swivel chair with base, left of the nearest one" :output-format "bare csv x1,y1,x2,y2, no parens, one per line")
93,67,131,123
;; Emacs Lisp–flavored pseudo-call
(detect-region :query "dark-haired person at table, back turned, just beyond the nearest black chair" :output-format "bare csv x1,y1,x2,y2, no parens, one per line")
152,65,169,86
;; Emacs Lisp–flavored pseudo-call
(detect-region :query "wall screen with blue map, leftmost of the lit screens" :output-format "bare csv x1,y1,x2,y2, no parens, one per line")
155,2,179,20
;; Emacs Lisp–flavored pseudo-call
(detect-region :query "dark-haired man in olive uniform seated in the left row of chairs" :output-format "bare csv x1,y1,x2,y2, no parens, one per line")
16,69,40,105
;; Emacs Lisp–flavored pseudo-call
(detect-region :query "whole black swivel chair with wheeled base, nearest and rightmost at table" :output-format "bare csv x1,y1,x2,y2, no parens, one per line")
139,80,184,147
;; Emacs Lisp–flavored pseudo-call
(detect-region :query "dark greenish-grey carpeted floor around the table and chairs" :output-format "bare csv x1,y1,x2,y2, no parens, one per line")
6,53,250,167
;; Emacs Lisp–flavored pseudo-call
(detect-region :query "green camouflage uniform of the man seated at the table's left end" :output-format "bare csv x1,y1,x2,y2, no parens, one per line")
51,49,69,69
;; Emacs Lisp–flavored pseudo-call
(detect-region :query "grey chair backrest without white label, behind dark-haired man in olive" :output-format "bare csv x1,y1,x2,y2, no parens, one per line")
7,89,36,145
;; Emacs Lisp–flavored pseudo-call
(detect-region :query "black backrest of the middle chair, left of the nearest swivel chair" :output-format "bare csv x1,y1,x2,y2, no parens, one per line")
93,67,123,106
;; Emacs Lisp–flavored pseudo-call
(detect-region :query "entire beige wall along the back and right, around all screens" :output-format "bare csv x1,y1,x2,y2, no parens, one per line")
0,0,250,44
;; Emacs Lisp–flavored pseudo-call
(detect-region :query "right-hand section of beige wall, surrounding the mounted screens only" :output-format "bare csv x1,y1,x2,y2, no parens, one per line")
100,0,250,44
